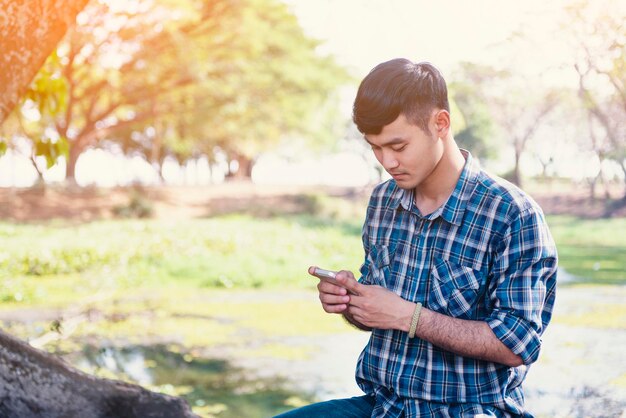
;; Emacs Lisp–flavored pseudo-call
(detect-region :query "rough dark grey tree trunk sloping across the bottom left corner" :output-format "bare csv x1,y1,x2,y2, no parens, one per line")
0,331,196,418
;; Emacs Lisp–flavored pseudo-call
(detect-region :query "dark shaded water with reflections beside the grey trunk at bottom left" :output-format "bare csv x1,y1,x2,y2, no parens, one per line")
64,345,313,418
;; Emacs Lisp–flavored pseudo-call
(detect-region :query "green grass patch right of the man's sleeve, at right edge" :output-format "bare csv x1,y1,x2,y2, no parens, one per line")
548,216,626,284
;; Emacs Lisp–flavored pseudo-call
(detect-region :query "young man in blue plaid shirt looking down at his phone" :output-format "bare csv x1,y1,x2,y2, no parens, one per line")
281,59,557,418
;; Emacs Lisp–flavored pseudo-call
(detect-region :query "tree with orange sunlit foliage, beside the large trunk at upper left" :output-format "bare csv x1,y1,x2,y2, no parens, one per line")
40,1,213,182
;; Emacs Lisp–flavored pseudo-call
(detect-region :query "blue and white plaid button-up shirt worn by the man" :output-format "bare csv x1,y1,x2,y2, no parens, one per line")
356,151,557,418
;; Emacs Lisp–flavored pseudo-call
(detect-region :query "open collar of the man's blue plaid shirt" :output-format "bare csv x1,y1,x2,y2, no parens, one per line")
389,149,480,225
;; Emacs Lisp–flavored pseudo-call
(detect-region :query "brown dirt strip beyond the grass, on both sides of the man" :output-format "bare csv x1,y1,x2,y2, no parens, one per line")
0,182,626,222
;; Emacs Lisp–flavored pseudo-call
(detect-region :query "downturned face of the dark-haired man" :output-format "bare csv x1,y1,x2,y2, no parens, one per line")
365,114,444,190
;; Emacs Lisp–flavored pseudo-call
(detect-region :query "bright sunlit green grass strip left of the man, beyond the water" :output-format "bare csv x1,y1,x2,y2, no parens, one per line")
0,215,363,303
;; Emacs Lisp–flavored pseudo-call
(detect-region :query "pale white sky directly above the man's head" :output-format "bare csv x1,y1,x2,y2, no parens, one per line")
285,0,566,78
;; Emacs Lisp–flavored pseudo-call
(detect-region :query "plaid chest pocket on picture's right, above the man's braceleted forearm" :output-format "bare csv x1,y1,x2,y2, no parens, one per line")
426,258,484,319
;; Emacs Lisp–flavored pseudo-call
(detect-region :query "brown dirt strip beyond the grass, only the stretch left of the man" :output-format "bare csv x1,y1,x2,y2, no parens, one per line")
0,182,362,222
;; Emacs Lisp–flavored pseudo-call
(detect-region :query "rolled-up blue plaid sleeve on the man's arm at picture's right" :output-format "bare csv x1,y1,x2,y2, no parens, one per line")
486,207,557,365
